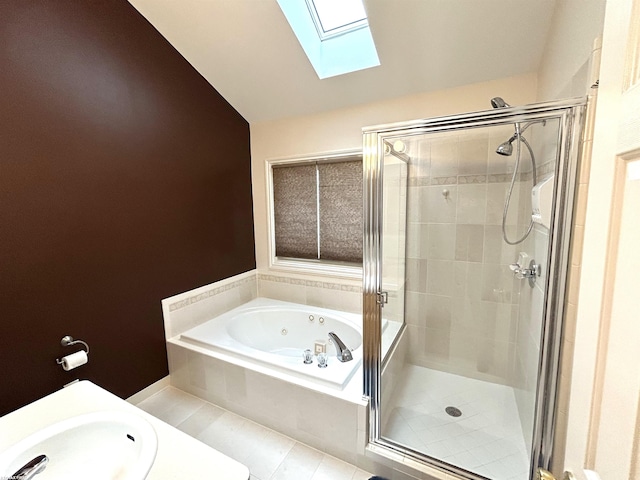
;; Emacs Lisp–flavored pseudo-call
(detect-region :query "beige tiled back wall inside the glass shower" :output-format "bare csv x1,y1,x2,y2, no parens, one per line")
406,126,544,385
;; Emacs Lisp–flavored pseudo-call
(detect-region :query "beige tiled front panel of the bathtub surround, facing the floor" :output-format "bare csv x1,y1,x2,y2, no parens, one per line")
167,342,367,464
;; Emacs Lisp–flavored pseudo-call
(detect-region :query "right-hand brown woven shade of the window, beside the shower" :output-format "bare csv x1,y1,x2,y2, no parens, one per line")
318,159,363,263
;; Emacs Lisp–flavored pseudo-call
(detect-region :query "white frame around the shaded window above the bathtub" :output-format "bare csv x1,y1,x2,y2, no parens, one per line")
265,149,363,280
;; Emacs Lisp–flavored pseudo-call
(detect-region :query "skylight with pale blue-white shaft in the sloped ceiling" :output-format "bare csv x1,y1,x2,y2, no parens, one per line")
277,0,380,79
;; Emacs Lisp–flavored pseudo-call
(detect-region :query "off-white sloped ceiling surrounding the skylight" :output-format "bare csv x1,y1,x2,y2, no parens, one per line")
129,0,556,123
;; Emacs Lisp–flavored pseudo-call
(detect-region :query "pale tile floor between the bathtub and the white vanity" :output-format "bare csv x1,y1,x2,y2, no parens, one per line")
137,387,372,480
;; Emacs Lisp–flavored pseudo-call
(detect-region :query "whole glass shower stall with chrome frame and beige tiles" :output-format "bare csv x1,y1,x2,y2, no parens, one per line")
364,97,585,480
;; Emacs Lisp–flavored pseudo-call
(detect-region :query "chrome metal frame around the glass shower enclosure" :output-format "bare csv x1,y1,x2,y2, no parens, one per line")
363,98,587,480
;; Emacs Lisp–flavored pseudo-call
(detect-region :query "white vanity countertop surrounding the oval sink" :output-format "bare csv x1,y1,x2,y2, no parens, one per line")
0,380,249,480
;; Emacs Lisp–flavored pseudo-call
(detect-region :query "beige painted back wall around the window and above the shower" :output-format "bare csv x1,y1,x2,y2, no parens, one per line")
251,71,536,271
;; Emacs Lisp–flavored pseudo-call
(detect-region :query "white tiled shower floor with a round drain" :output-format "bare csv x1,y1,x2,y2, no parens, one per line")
382,365,529,480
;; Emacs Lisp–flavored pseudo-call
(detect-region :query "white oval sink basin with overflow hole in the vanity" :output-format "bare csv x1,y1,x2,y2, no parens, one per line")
0,411,158,480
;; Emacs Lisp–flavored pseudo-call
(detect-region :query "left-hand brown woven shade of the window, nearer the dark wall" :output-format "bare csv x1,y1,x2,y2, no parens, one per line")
273,164,318,259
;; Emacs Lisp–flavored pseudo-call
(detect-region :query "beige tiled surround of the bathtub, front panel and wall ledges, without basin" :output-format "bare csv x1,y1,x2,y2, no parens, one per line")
163,272,384,465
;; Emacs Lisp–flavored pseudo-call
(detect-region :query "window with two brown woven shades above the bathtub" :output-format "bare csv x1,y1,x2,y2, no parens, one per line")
270,154,362,276
